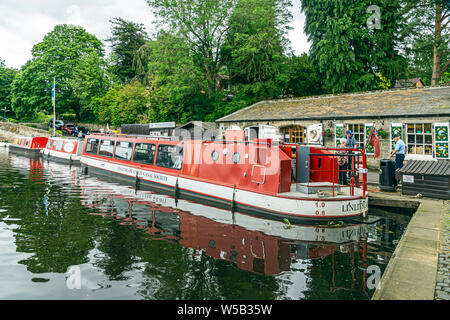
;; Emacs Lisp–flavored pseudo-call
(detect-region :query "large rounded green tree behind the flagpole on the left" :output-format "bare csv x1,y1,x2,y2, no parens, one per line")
12,25,108,117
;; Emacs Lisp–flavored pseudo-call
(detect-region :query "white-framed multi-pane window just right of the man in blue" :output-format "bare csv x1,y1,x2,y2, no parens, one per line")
406,123,433,156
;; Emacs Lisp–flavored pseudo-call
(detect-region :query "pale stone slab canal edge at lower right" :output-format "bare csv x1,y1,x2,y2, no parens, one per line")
372,199,449,300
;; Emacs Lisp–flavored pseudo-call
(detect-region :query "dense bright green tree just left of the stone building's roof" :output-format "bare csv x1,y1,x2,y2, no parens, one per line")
135,32,212,122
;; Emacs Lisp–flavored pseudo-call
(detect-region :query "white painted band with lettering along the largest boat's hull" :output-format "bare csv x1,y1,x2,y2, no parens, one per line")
81,157,368,219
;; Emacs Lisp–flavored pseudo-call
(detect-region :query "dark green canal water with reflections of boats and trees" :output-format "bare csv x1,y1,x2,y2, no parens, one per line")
0,149,409,300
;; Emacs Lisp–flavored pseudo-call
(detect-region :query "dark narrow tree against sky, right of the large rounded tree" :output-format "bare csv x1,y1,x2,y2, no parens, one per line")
106,18,148,83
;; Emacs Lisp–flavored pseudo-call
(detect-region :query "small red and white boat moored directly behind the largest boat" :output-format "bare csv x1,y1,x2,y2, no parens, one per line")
42,137,84,164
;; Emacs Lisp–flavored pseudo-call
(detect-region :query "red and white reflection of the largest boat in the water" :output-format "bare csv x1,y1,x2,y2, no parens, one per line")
80,172,367,275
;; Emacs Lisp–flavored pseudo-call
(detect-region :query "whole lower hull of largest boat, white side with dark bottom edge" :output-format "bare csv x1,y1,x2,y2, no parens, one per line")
81,156,368,223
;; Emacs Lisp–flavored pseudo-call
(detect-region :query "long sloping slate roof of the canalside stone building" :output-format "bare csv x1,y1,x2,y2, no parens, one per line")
216,86,450,122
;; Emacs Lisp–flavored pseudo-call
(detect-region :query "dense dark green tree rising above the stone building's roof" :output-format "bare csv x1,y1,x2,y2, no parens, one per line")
302,0,406,92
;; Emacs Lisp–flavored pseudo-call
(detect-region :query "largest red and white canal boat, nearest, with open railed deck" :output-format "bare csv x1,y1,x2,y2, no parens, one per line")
81,135,368,222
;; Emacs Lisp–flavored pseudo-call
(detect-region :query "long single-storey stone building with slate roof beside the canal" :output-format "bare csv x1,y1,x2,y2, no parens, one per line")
216,87,450,167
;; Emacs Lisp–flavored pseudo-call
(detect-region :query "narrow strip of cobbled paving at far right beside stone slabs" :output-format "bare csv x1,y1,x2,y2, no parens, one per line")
434,204,450,300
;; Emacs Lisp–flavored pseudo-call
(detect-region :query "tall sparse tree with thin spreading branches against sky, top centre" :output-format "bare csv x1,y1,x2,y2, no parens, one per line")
146,0,237,97
